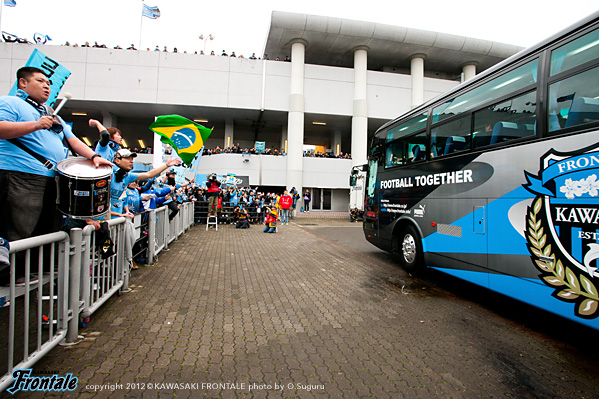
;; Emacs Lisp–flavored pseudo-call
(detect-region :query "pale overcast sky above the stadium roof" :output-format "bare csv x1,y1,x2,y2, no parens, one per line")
1,0,599,57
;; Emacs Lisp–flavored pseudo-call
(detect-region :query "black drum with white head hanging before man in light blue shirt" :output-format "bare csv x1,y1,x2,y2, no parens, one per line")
56,157,112,219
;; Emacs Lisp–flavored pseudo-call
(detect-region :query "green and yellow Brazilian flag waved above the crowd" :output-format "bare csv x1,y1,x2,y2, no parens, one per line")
150,115,212,167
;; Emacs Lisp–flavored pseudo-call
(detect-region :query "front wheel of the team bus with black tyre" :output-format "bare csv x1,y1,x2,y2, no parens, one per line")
393,219,424,274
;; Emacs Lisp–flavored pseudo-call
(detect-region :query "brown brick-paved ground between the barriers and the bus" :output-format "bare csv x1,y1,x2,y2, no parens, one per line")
4,218,599,398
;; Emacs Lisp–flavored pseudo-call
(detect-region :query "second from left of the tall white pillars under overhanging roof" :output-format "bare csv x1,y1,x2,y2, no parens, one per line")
351,46,368,166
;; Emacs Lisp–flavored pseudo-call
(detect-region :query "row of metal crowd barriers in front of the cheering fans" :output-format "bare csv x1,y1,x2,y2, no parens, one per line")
0,203,194,392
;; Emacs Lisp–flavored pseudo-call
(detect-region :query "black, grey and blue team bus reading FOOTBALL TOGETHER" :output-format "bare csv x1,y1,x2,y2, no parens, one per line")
363,12,599,329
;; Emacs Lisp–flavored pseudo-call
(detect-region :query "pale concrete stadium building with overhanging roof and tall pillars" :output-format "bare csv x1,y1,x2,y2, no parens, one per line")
0,12,522,211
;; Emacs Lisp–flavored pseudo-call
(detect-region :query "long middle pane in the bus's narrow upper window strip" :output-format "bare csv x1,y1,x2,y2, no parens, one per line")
433,59,538,123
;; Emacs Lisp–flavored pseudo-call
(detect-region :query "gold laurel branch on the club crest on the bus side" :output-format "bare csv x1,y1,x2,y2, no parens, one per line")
527,197,599,319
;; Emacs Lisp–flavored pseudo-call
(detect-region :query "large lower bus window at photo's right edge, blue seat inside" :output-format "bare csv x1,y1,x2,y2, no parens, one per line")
547,67,599,132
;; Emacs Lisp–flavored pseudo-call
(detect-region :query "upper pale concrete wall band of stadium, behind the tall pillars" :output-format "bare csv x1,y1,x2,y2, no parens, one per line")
0,43,458,119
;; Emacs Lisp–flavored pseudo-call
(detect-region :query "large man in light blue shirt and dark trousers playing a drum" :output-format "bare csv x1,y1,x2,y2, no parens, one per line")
0,67,112,279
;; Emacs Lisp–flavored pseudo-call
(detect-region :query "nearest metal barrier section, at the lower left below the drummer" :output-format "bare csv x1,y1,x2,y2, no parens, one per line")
0,232,72,392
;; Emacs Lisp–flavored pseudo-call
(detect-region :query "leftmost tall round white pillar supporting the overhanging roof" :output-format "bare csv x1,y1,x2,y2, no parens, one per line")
287,39,307,193
